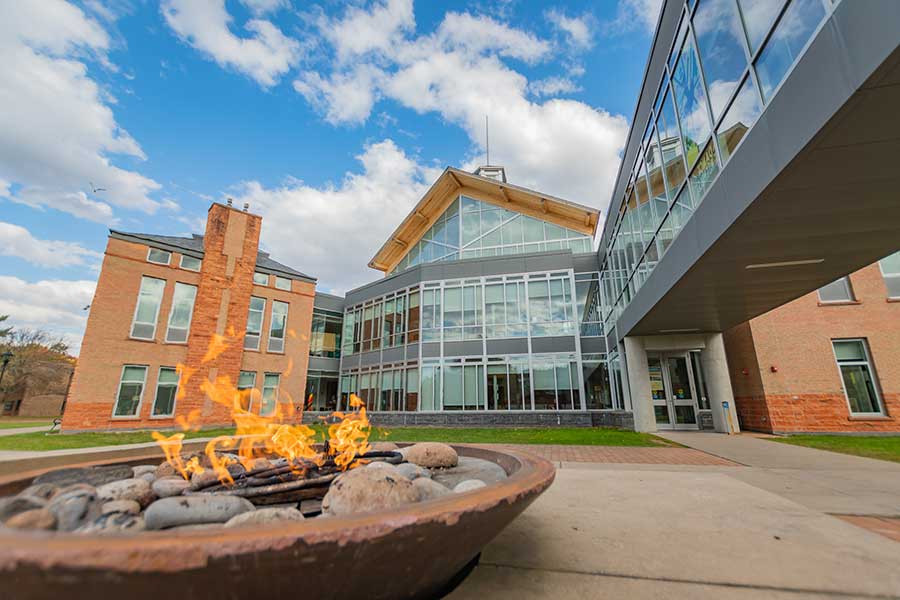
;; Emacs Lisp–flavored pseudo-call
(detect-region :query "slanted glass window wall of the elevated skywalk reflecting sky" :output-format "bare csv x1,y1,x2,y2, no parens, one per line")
600,0,837,329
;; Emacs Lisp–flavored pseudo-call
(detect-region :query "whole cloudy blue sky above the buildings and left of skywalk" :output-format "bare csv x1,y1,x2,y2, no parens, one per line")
0,0,659,351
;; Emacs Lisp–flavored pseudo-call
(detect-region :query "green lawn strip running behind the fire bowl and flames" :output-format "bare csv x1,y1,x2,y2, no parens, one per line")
0,425,669,451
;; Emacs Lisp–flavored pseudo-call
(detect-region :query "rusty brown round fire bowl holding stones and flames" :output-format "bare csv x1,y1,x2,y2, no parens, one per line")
0,446,555,600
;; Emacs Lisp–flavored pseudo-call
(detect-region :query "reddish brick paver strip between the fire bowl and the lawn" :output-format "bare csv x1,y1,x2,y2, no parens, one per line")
483,444,740,467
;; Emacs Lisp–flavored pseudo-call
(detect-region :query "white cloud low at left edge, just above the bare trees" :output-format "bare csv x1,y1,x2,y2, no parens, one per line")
0,275,96,354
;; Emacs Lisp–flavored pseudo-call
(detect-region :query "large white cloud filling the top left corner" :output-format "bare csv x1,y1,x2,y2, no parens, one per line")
0,0,159,222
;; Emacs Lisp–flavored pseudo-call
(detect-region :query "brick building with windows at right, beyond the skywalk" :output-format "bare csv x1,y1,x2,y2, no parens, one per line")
725,260,900,433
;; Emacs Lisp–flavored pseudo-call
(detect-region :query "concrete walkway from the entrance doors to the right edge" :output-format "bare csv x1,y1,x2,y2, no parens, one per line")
659,432,900,517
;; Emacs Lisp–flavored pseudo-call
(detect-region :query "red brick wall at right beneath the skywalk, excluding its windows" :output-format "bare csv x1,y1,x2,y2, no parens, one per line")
726,264,900,432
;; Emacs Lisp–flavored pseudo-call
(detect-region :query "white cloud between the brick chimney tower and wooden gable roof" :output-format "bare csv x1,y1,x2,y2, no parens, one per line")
234,139,440,293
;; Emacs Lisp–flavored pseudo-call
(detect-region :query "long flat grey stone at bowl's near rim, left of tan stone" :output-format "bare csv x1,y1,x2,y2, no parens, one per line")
144,494,254,529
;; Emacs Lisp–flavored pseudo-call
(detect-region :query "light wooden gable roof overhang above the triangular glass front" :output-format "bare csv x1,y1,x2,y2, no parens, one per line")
369,167,600,273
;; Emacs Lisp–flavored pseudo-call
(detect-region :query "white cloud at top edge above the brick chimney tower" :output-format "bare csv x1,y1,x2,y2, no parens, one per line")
162,0,300,88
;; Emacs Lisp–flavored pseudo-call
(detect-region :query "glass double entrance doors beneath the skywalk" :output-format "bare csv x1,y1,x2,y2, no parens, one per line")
647,352,698,429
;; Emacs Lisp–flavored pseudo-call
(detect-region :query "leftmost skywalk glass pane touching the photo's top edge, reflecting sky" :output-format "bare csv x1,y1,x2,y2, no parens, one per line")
693,0,747,120
